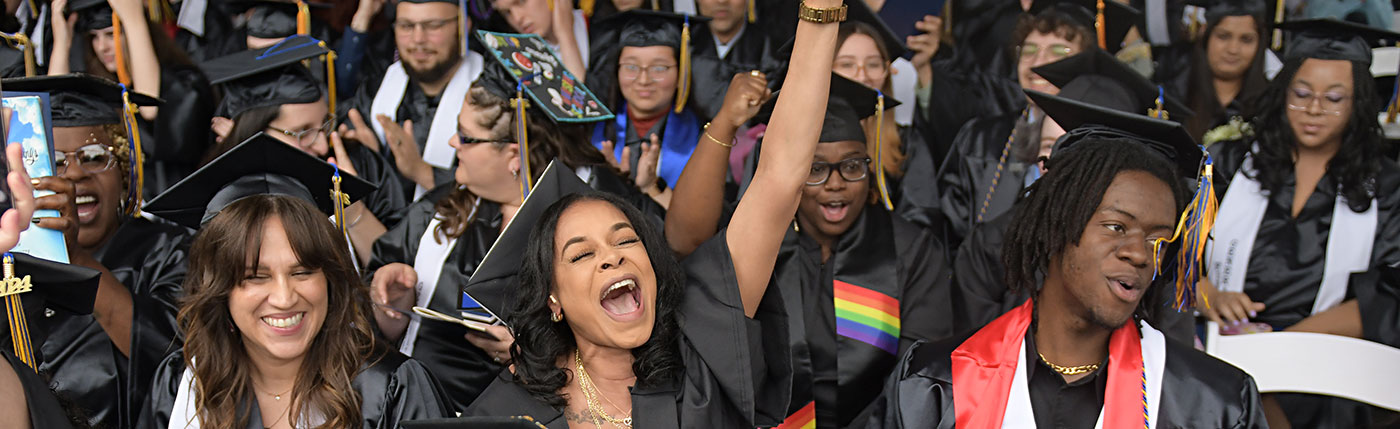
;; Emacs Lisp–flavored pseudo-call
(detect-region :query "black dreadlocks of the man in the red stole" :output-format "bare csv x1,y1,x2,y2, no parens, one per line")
1001,137,1190,325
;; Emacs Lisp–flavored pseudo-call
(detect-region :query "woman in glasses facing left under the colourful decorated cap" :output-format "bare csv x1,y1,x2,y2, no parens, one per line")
367,39,661,411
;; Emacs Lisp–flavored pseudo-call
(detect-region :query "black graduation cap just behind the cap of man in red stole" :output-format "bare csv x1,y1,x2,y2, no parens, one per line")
1032,49,1193,121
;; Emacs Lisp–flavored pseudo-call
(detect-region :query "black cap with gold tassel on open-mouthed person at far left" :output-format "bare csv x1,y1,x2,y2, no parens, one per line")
0,73,161,216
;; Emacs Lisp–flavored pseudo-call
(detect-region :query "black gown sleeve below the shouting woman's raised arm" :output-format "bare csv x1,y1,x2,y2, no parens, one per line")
679,230,792,428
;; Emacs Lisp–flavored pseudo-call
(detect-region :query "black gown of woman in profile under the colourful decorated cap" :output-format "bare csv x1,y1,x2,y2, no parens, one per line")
365,184,501,411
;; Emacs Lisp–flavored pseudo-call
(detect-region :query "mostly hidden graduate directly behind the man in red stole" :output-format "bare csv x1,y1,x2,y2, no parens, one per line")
952,48,1194,337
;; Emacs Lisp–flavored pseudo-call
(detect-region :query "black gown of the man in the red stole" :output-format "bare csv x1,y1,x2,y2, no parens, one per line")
868,301,1267,429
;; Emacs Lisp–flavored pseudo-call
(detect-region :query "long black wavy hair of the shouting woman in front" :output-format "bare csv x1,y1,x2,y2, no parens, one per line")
504,193,686,408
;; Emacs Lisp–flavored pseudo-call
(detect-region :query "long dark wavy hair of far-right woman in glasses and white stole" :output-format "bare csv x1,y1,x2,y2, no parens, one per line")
1252,59,1385,212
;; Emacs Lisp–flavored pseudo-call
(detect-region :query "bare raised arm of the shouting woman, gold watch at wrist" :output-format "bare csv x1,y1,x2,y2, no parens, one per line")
727,0,841,317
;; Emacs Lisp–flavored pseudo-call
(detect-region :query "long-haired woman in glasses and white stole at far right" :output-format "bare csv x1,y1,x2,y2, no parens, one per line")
1203,21,1400,428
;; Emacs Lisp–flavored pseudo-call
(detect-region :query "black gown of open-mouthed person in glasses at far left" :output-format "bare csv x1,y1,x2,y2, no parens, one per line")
39,219,190,428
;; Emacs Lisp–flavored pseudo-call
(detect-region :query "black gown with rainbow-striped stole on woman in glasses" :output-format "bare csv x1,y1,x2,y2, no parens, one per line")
773,206,952,428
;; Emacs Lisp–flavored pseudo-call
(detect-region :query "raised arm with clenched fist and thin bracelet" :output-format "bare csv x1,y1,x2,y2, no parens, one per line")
666,72,773,257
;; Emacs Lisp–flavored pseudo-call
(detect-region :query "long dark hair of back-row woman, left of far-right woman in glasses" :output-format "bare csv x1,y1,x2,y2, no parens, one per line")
1182,15,1270,142
